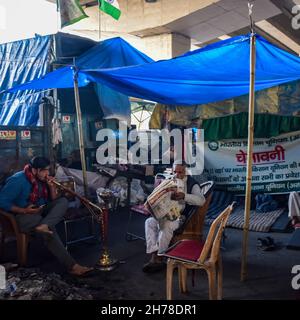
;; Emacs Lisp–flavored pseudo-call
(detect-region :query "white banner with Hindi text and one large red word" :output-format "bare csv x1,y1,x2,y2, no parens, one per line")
204,131,300,194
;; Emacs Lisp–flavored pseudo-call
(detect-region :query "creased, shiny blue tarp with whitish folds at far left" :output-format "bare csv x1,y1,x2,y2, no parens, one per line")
0,36,51,126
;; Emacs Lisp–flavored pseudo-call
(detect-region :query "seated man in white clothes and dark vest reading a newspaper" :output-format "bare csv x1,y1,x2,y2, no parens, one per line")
143,164,205,272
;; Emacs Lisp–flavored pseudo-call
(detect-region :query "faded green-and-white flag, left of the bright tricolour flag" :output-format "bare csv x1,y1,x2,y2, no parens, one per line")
57,0,88,28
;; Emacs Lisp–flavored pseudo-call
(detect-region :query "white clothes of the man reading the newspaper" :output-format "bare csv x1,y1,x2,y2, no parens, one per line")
145,177,205,253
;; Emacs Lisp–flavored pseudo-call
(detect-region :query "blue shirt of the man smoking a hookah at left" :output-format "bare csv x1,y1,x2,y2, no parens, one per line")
0,171,46,211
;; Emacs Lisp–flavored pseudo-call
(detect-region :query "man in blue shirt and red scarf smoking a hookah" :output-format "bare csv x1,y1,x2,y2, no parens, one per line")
0,157,91,275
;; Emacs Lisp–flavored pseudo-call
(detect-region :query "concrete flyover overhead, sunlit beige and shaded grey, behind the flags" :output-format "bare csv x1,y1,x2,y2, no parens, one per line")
47,0,300,55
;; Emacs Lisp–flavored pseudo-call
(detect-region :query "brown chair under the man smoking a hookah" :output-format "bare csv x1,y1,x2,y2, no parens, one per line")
0,209,29,266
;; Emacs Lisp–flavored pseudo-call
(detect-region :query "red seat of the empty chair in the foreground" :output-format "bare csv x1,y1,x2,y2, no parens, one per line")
164,240,205,262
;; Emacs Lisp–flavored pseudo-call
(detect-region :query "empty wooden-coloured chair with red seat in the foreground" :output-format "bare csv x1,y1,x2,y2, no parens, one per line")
161,203,234,300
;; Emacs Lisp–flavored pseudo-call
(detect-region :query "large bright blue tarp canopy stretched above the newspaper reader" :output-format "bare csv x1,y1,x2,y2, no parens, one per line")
6,35,300,105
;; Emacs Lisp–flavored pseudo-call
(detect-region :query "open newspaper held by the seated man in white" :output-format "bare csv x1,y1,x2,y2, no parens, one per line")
145,179,182,221
